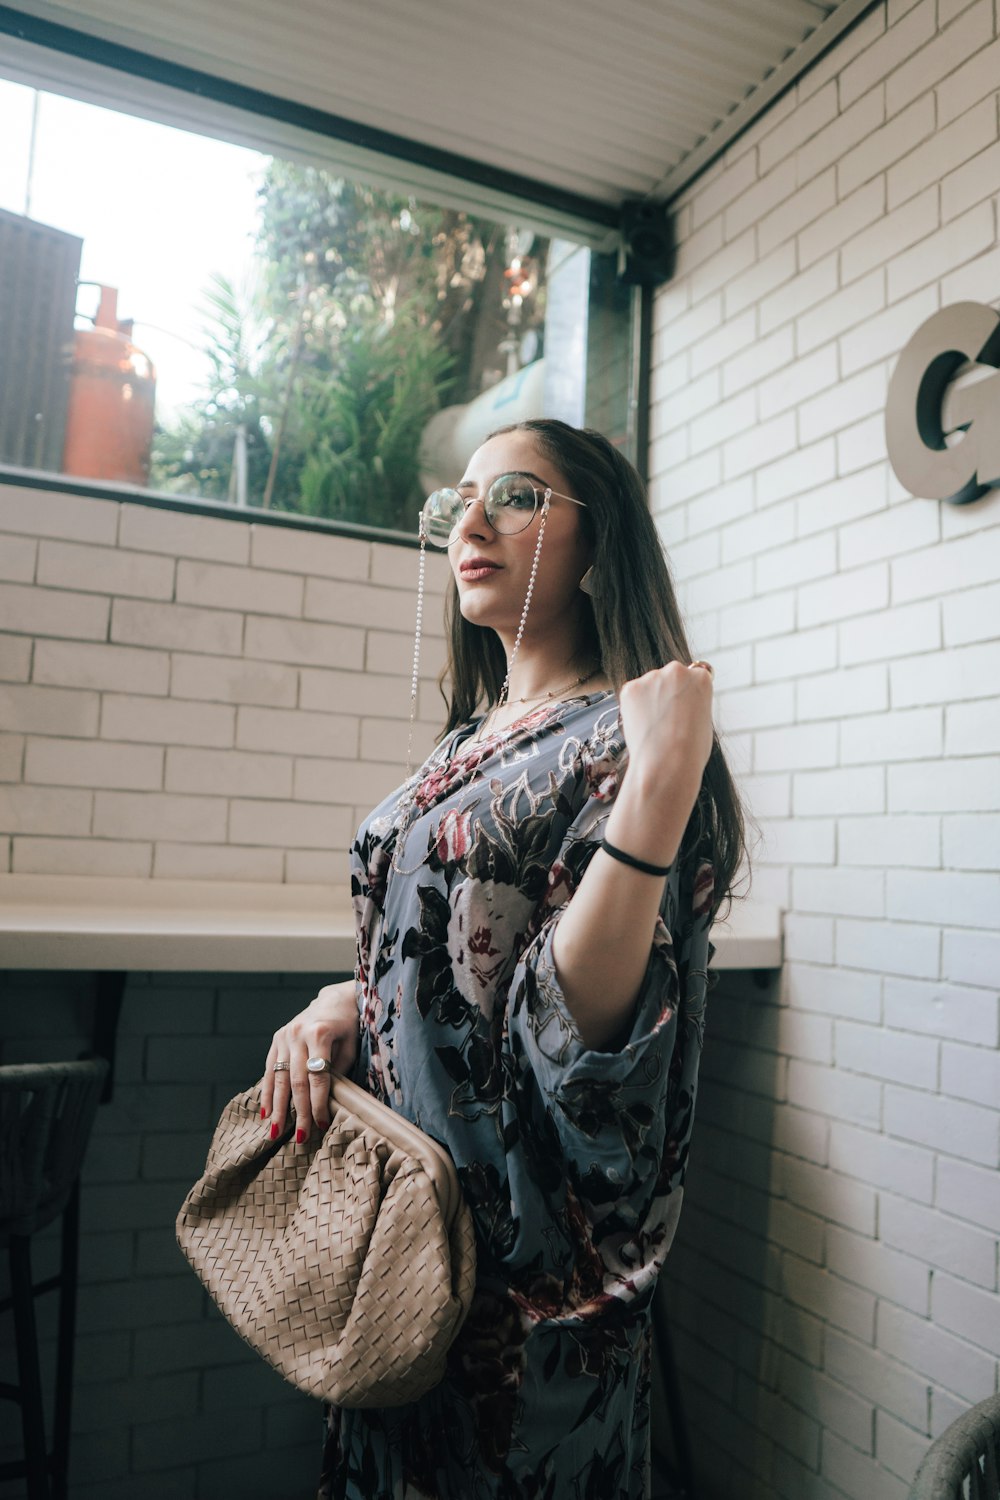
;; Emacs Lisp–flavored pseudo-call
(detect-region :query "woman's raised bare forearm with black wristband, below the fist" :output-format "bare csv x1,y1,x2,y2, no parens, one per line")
553,762,700,1049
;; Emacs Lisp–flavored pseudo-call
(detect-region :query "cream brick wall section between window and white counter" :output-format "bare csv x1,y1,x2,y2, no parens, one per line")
0,485,447,882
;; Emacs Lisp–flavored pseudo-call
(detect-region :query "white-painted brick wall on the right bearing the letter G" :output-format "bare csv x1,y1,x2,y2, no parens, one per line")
652,0,1000,1500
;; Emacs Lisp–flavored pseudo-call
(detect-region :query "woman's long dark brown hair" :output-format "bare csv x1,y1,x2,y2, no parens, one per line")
441,417,750,917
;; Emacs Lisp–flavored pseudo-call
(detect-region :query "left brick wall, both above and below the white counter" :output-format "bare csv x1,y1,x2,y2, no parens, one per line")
0,501,447,1500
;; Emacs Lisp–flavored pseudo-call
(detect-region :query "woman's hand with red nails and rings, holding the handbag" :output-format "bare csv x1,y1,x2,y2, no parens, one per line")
261,980,360,1142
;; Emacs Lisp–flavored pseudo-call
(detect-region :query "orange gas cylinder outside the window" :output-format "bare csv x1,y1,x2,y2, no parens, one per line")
63,287,156,485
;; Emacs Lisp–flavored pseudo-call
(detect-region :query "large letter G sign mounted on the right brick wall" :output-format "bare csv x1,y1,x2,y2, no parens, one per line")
886,302,1000,504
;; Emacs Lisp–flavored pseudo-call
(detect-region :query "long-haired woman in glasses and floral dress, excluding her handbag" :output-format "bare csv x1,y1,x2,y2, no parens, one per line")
264,420,742,1500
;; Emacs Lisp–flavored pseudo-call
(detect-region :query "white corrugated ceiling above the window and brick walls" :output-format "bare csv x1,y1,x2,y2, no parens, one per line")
0,0,867,237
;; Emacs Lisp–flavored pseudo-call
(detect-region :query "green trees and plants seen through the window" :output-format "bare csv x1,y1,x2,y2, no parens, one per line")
151,161,541,531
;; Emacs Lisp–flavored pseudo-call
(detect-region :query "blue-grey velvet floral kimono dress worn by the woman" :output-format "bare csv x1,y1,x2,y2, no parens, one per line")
319,692,714,1500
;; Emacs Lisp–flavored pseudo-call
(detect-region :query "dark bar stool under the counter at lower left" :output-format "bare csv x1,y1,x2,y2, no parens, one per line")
0,1058,108,1500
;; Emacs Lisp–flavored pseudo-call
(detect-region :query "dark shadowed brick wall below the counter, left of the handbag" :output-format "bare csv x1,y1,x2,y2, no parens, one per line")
0,971,340,1500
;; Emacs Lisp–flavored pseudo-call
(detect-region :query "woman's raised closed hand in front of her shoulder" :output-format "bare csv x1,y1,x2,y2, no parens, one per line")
618,662,712,791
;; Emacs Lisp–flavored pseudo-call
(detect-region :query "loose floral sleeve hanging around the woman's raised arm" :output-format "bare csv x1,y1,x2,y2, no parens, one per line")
507,726,714,1220
